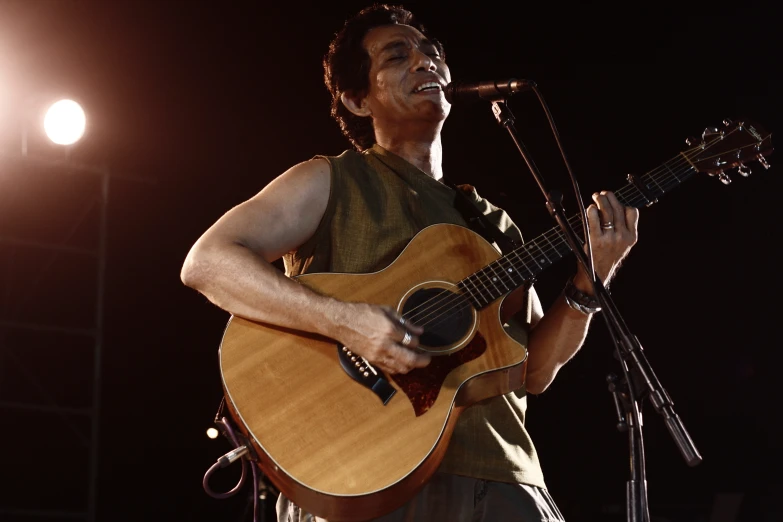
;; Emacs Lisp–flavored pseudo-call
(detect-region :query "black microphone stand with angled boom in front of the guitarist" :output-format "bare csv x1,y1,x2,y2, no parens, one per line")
486,94,702,522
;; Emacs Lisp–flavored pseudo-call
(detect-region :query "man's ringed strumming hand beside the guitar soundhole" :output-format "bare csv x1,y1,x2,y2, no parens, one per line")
336,303,431,373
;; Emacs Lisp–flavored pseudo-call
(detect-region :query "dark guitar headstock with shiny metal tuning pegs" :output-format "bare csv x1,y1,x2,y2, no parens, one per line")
682,120,773,185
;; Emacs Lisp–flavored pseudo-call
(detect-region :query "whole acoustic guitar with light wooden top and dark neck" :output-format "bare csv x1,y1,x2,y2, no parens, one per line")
219,122,772,521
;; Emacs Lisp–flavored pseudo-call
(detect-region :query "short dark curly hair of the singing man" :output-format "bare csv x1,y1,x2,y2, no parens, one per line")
323,4,443,151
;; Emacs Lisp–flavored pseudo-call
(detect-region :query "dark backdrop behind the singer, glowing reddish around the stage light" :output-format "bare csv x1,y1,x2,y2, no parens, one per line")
0,0,783,522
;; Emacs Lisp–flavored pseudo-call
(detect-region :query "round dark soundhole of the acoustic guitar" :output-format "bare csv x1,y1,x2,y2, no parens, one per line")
402,288,473,351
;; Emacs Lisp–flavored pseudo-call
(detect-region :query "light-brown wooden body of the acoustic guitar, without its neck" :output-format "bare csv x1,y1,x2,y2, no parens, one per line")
220,224,527,521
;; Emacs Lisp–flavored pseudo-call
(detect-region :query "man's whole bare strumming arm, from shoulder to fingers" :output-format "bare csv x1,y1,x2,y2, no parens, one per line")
181,159,429,373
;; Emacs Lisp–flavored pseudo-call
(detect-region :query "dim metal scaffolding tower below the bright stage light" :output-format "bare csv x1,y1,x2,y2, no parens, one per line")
0,149,146,522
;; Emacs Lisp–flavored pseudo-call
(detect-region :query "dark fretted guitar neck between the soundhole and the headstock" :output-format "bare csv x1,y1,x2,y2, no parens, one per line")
458,147,698,309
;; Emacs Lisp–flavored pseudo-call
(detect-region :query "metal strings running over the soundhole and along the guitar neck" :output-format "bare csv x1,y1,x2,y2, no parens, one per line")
404,129,756,336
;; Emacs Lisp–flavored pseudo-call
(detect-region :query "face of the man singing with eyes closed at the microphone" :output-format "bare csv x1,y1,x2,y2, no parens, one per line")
364,25,451,127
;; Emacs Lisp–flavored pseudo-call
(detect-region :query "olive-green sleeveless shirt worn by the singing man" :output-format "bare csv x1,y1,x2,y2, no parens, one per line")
283,144,546,488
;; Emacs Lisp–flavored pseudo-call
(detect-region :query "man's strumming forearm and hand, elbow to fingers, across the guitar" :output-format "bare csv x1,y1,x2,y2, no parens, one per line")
182,243,430,373
